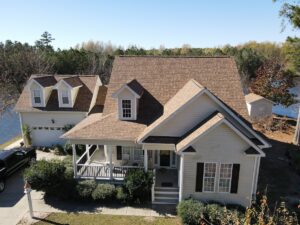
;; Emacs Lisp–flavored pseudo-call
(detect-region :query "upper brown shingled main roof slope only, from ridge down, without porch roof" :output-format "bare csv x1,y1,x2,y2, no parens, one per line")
104,56,248,119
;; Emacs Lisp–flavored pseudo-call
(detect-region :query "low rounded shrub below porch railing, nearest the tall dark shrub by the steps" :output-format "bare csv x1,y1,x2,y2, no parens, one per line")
92,184,116,201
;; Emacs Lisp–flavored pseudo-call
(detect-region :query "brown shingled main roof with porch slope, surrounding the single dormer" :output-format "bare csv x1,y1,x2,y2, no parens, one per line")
64,56,248,141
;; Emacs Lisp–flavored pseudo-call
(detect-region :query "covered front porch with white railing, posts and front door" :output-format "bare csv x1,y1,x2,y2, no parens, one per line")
72,144,178,183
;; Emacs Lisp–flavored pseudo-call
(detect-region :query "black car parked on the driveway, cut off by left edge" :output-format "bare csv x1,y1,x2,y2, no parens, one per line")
0,148,36,192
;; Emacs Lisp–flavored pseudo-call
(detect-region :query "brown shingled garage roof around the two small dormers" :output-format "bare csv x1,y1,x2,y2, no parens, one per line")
15,75,98,112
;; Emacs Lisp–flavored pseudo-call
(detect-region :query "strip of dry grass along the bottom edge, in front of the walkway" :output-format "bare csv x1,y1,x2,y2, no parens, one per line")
35,213,181,225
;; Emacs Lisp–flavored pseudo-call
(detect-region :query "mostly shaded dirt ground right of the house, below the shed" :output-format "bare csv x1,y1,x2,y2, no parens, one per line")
254,124,300,213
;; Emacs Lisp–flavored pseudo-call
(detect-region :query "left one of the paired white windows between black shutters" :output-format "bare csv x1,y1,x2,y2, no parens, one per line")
203,163,217,192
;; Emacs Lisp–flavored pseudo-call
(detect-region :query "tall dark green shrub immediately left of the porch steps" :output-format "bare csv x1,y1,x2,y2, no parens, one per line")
124,169,153,203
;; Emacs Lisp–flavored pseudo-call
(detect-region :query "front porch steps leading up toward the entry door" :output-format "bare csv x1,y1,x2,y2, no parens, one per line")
152,187,179,204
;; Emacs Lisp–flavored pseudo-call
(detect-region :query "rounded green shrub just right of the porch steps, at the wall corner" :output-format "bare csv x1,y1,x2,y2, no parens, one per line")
177,199,205,225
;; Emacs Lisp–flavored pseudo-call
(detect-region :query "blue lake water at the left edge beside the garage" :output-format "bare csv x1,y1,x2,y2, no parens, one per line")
0,108,21,144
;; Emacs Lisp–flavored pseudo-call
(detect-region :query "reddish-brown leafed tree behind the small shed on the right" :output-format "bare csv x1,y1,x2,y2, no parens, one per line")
250,59,294,106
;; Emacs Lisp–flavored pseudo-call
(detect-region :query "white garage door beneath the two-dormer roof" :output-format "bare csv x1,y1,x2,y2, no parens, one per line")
31,127,65,146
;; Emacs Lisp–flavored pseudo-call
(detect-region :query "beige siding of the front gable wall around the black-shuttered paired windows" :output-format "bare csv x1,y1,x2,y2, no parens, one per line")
182,124,255,206
